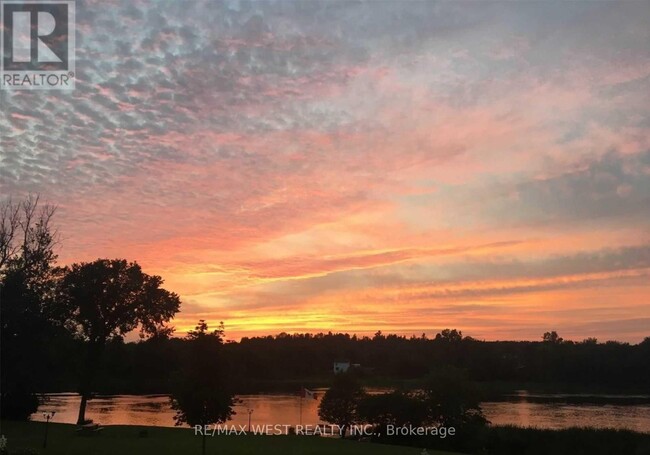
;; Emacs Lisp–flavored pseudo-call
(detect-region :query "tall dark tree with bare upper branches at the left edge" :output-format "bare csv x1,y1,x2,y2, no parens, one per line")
0,196,57,420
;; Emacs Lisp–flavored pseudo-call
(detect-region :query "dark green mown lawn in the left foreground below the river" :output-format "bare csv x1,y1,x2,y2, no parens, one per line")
0,421,456,455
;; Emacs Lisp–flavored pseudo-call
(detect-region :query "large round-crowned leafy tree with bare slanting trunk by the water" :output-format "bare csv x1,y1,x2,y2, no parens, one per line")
57,259,180,425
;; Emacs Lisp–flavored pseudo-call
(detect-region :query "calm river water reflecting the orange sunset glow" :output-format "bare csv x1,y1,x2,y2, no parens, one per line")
32,393,650,433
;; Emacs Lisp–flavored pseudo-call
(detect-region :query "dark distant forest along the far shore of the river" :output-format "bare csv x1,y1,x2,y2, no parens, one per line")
38,330,650,394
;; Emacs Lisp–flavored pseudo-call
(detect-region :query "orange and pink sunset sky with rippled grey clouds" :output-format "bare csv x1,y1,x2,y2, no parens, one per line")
0,0,650,343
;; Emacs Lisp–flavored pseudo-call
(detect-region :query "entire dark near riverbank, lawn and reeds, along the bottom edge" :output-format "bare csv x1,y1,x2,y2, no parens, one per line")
5,421,650,455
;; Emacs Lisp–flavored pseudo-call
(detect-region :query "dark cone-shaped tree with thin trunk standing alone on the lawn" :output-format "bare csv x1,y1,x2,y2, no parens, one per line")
172,320,235,454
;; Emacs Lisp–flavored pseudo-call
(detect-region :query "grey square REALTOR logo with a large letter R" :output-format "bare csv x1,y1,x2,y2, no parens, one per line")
0,0,75,90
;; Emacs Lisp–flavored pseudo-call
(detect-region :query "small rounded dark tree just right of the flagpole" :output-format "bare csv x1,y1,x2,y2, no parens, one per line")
318,372,365,437
